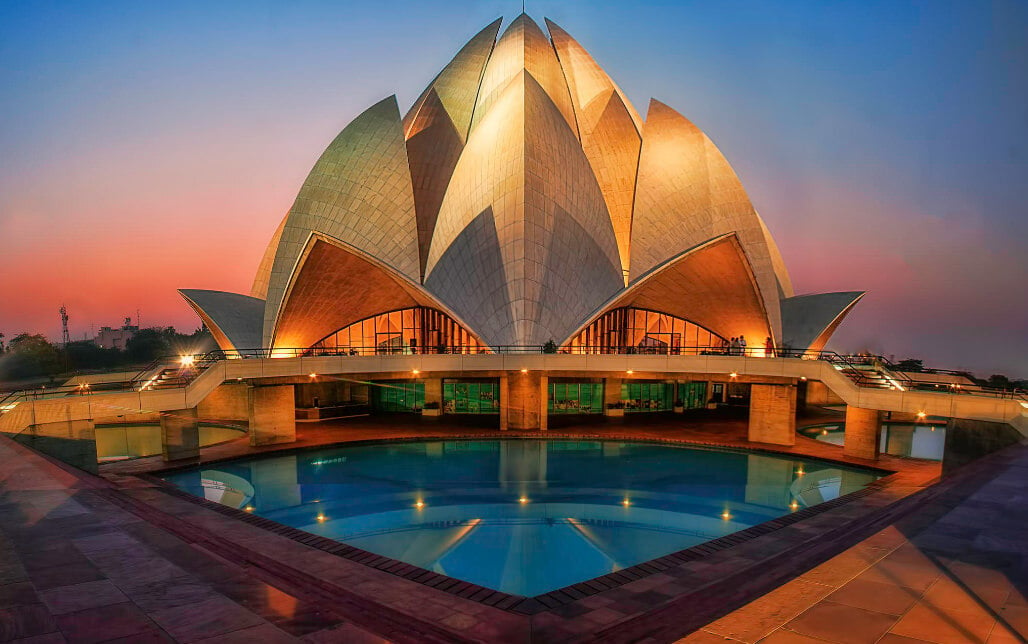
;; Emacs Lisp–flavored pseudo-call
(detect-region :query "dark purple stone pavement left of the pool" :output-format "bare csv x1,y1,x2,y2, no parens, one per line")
0,438,382,644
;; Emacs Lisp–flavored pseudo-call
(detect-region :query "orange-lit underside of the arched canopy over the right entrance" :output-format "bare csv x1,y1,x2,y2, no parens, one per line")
563,234,771,347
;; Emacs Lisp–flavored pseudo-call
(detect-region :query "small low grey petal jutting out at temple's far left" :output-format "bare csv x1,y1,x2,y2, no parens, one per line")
179,288,264,351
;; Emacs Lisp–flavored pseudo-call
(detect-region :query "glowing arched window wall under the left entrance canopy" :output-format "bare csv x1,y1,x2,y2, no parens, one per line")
307,307,488,356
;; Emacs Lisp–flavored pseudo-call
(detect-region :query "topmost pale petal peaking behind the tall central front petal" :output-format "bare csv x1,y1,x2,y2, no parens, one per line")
471,13,578,135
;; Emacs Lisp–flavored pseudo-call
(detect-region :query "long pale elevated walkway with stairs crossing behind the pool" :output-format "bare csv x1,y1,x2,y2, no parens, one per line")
0,353,1028,436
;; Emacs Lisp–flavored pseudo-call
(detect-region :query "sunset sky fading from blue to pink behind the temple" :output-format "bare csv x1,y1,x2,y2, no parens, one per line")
0,0,1028,377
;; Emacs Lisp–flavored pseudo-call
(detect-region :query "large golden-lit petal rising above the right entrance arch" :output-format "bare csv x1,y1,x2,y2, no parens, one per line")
630,100,781,337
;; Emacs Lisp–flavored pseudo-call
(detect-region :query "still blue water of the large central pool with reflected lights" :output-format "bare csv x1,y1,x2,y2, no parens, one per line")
166,439,879,597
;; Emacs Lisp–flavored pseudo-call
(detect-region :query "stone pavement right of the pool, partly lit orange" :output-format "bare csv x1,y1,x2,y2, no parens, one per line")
682,445,1028,644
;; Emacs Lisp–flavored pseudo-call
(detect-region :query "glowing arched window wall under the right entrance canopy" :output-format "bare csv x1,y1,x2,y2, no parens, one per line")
562,308,727,355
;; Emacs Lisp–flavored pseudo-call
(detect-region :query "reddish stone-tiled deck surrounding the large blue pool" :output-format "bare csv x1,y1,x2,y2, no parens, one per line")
0,413,1028,642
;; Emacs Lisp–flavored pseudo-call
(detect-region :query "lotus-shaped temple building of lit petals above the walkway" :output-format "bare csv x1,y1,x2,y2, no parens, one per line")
182,14,862,355
